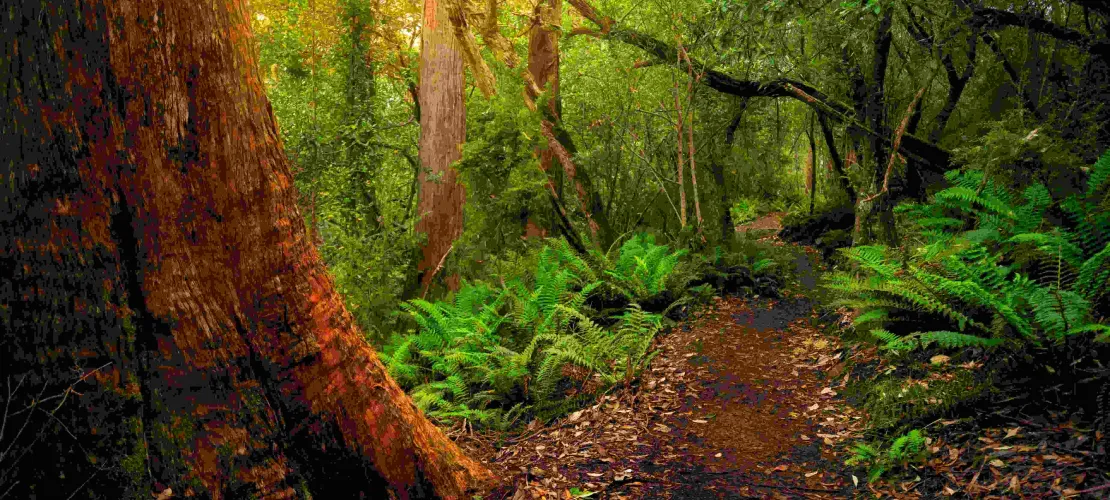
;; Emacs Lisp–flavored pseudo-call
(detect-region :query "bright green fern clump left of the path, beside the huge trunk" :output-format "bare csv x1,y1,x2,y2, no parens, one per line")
381,234,685,428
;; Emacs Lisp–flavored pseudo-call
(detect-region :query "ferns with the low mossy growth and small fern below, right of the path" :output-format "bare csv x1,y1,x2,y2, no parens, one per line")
824,151,1110,480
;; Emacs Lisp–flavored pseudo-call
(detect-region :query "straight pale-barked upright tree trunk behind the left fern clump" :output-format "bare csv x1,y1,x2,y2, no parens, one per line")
416,0,466,290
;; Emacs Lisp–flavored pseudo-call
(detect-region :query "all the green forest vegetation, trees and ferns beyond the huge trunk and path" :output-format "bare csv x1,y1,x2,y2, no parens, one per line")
253,0,1110,486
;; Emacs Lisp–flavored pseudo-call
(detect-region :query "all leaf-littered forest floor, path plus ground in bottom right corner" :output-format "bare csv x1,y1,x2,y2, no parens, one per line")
450,228,1110,500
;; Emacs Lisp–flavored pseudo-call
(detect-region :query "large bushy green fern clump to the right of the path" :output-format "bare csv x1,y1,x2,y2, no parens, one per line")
827,153,1110,351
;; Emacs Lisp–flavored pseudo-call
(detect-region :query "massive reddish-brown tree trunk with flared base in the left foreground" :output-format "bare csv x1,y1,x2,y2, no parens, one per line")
0,0,490,498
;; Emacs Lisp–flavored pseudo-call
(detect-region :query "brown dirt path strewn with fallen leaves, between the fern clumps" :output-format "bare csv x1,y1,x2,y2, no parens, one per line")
458,298,866,499
